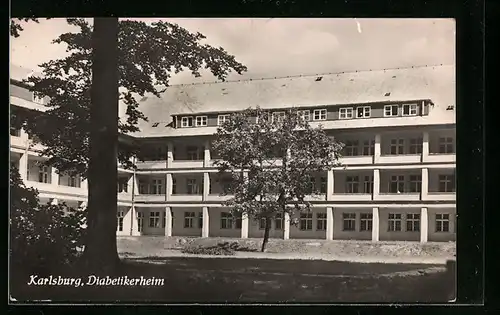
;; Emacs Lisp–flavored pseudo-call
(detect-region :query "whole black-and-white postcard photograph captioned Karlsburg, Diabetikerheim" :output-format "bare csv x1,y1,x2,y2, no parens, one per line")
9,17,462,304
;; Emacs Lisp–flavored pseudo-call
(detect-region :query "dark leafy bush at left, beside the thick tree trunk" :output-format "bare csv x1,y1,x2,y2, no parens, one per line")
9,167,85,275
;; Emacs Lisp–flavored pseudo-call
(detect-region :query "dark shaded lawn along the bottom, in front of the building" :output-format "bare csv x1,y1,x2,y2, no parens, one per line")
11,257,454,303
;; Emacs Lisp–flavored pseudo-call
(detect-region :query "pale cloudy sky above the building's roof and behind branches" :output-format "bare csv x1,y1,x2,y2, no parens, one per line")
11,18,455,84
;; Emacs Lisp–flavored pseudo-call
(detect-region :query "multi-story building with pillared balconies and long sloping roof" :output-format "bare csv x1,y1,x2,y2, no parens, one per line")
10,66,456,242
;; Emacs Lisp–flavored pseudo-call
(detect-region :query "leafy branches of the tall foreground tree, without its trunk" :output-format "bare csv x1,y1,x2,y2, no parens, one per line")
11,18,247,176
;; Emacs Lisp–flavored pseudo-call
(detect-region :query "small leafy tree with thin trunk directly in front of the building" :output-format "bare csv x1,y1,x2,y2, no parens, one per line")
213,108,342,251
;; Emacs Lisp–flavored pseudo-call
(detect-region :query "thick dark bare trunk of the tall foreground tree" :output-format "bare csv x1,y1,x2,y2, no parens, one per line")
84,18,120,274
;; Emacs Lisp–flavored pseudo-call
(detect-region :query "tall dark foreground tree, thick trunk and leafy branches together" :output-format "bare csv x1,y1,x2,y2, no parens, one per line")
11,18,247,271
